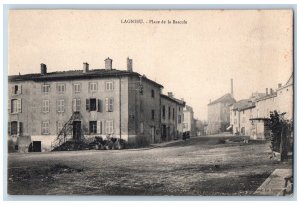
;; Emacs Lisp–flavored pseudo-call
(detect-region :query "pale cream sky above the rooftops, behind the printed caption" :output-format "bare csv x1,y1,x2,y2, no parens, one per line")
8,10,293,120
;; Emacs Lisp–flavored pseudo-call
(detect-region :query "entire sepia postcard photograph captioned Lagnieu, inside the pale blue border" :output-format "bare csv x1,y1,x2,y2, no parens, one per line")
6,9,295,198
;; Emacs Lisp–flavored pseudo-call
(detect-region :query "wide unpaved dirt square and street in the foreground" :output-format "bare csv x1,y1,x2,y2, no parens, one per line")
8,137,291,196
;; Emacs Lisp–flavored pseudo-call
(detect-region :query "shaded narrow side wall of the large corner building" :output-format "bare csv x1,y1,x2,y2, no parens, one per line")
128,77,161,144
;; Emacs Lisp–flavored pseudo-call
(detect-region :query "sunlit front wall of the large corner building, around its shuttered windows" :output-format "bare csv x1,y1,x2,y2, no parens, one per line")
9,77,133,150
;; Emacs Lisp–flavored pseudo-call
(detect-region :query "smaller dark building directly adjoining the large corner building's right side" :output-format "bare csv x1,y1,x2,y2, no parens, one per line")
161,92,185,141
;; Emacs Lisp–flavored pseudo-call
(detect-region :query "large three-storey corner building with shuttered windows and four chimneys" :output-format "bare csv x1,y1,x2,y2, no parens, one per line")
8,58,182,151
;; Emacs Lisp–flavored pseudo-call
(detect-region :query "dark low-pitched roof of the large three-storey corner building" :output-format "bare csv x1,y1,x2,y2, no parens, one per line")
8,69,163,88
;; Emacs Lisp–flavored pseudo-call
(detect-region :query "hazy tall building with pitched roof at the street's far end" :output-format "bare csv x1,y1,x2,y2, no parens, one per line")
206,93,236,135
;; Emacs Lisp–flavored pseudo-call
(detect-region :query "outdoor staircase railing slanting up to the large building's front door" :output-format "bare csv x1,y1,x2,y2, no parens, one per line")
51,112,80,151
